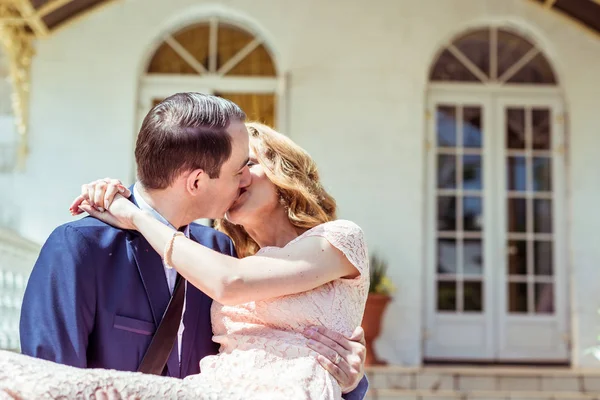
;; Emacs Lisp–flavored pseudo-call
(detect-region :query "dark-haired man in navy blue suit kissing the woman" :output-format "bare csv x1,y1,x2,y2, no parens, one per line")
20,93,368,399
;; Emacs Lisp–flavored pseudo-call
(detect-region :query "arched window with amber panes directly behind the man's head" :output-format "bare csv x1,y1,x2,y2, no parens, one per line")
140,18,278,126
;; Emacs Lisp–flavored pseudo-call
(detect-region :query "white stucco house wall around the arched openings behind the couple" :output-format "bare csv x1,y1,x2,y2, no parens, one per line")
0,0,600,365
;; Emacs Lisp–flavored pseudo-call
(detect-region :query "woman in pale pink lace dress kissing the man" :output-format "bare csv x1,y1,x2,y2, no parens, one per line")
0,123,369,400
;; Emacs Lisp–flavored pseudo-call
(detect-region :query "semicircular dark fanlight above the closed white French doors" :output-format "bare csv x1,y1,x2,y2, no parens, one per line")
429,27,558,85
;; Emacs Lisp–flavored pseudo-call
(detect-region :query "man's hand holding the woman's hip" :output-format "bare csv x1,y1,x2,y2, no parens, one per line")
304,326,367,394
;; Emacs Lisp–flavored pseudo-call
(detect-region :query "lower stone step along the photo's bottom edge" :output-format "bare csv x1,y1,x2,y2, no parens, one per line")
365,389,600,400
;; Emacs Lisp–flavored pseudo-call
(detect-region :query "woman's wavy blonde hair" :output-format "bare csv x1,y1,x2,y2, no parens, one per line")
215,122,337,258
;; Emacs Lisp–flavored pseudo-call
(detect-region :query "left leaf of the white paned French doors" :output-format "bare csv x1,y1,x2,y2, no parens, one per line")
425,96,493,359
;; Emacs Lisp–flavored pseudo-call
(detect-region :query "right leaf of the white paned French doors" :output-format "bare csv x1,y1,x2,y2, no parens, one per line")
495,96,569,361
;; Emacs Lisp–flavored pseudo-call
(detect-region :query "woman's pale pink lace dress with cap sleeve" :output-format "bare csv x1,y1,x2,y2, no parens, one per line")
0,220,369,400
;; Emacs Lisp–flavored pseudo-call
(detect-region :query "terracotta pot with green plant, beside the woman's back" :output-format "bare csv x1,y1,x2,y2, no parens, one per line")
362,254,396,365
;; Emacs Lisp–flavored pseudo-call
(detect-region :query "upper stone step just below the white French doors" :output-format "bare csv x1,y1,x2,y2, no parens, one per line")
366,367,600,394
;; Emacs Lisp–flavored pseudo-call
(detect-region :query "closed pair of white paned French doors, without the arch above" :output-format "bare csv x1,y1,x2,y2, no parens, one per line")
424,90,569,362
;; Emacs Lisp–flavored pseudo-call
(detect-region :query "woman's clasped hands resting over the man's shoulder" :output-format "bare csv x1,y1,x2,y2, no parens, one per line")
69,178,142,230
